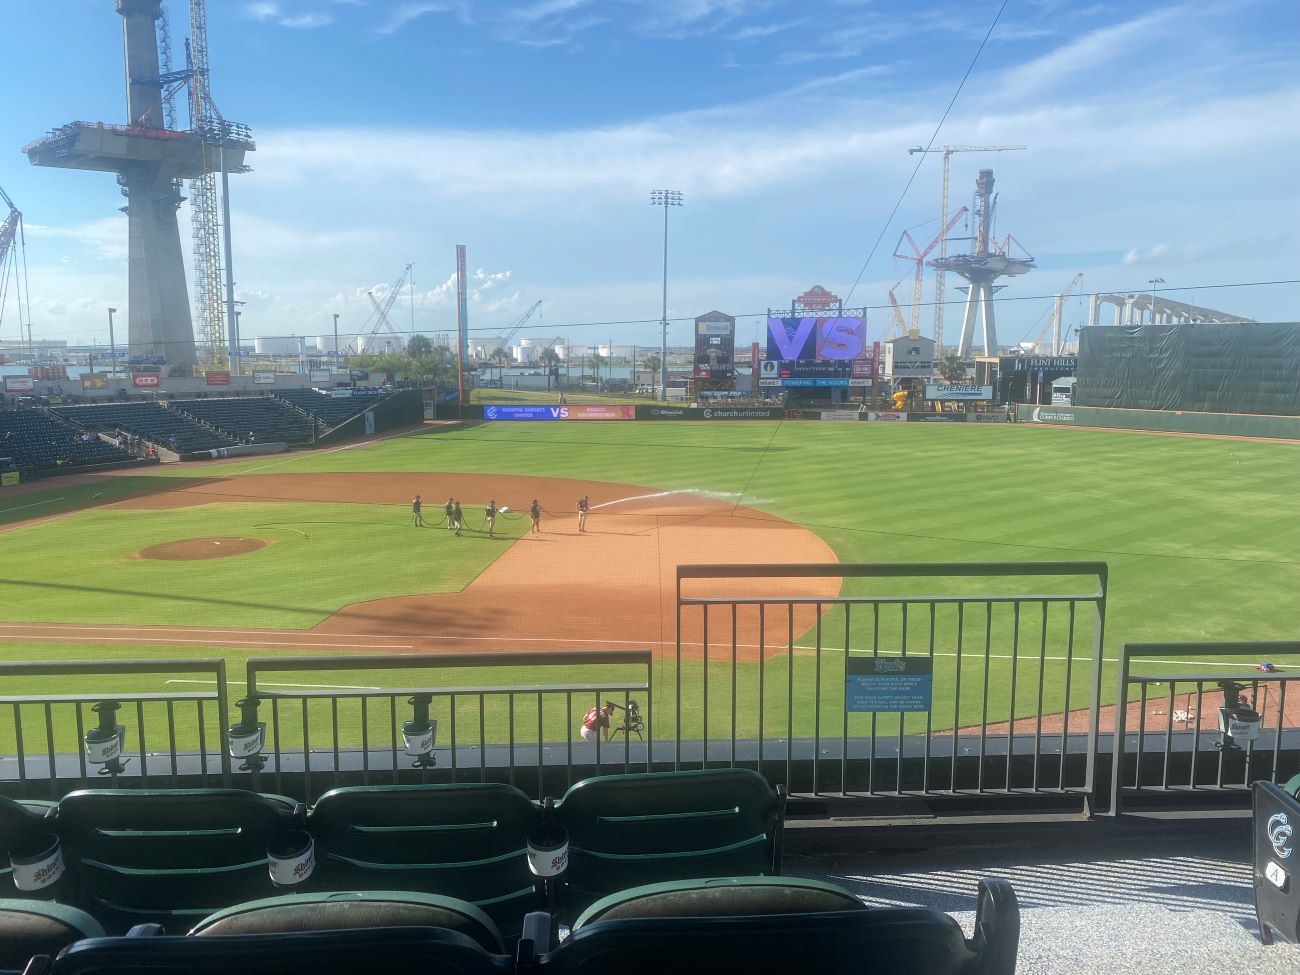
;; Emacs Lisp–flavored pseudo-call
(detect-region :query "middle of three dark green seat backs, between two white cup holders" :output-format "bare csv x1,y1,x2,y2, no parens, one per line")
307,783,541,931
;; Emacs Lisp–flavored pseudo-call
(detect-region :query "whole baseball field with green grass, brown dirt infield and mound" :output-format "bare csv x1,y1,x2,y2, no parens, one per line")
0,421,1300,748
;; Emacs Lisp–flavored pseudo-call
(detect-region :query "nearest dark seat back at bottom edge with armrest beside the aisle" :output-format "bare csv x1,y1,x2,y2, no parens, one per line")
538,880,1019,975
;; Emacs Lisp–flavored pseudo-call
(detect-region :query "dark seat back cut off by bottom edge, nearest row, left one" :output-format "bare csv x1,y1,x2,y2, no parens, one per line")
36,928,514,975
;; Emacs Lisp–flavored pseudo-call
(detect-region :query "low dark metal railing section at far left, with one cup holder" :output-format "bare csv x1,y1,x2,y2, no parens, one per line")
0,659,230,800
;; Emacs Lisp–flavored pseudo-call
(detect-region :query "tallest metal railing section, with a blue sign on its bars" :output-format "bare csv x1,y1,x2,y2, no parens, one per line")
672,563,1106,803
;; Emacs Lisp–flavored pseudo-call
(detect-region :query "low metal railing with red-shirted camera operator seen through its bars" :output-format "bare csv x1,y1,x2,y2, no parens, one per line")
237,650,653,800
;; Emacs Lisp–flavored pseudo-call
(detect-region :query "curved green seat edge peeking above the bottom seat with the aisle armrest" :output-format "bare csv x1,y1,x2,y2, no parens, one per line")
573,876,867,931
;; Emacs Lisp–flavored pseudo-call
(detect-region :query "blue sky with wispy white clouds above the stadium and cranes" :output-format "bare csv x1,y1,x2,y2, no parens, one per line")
0,0,1300,345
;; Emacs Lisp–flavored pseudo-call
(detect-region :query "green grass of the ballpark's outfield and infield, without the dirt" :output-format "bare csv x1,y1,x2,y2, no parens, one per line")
0,423,1300,746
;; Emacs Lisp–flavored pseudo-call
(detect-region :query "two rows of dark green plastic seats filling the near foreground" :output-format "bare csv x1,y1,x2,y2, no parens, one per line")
0,770,1019,975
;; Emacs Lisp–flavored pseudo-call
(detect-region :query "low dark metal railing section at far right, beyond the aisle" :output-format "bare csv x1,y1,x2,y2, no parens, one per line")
1110,642,1300,815
